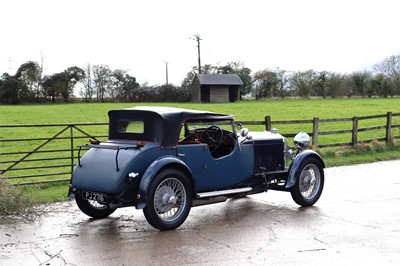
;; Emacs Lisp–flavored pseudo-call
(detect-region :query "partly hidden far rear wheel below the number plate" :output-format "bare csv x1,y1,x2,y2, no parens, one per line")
75,193,116,219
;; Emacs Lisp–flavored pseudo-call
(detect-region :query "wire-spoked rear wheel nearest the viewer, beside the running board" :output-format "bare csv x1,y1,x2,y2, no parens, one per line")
143,169,192,231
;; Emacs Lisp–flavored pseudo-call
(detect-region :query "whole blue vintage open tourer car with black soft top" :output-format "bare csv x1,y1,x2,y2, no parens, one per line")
68,107,325,230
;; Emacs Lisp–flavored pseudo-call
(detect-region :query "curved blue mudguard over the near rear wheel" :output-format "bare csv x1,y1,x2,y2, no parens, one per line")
136,156,192,209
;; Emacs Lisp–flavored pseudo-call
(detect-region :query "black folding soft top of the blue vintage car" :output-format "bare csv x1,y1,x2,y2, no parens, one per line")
108,106,234,148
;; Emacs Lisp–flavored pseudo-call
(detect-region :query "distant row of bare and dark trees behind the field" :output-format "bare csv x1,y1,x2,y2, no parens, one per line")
0,55,400,104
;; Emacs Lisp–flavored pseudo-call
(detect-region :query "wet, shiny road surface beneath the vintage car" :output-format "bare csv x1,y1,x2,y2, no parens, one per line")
0,160,400,265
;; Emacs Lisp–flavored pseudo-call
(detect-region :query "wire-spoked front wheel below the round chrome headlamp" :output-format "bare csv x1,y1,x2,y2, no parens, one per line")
290,158,324,207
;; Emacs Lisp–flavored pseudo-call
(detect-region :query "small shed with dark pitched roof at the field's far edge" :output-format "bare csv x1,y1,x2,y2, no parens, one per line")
190,74,243,103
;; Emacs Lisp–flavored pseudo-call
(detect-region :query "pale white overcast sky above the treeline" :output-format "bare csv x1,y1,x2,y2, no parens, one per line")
0,0,400,85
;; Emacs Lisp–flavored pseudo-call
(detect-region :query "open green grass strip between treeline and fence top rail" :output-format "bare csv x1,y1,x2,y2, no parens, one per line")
0,98,400,124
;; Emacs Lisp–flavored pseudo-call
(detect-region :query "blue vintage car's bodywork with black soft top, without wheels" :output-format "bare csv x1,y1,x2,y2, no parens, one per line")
69,107,324,213
